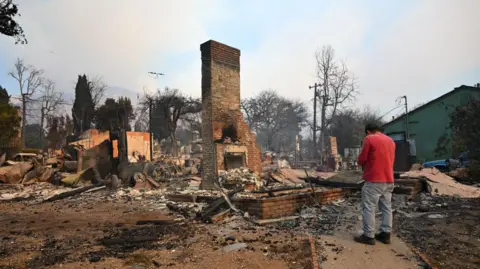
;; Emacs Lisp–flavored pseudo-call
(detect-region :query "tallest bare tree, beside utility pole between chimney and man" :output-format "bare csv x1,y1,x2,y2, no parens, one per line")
315,45,357,156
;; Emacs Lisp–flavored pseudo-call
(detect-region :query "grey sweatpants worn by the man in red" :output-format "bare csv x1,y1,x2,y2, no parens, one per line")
362,182,394,238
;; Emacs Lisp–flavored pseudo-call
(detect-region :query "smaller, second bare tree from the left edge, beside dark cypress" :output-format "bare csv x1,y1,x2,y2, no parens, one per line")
37,79,65,147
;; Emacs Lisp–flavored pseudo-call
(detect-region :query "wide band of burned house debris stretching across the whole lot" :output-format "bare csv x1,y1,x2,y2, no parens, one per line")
0,151,480,268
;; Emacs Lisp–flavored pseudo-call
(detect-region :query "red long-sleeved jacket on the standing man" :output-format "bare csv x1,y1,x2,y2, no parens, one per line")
358,133,395,183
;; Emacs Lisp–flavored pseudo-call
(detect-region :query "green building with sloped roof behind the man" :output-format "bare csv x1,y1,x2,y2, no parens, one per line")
383,84,480,162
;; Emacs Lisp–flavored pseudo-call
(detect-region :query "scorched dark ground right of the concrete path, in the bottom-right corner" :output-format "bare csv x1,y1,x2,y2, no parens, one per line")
393,194,480,269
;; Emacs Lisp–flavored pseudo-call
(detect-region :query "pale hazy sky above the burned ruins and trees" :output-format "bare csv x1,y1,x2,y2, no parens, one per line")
0,0,480,117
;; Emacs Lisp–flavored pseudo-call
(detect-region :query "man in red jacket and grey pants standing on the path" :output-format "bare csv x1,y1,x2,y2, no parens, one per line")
355,124,395,245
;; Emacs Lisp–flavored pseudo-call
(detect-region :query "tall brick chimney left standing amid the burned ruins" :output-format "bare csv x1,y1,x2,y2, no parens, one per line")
200,40,261,189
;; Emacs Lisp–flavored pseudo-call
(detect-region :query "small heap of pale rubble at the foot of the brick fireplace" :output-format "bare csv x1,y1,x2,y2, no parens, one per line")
218,168,263,189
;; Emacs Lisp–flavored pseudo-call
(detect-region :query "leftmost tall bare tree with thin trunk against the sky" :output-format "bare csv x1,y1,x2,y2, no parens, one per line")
8,58,43,147
